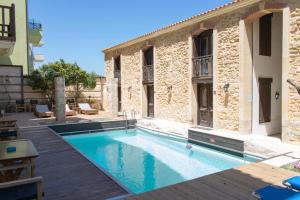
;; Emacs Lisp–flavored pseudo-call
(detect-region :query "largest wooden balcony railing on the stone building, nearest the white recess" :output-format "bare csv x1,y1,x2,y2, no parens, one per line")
193,55,213,78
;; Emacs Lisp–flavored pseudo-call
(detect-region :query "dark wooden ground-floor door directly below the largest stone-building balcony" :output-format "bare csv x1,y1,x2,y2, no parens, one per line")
198,83,213,127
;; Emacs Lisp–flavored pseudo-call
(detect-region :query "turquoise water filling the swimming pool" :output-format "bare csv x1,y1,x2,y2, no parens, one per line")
64,129,260,194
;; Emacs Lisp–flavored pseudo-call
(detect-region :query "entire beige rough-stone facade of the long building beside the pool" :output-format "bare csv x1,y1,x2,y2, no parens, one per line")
105,0,300,141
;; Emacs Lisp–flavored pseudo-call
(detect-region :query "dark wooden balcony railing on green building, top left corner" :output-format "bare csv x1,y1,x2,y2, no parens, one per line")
0,4,16,41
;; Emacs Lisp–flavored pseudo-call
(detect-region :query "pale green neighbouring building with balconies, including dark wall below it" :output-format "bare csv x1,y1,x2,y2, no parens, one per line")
0,0,43,111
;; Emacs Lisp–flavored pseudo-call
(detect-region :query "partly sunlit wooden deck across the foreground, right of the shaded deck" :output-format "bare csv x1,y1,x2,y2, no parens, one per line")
127,163,299,200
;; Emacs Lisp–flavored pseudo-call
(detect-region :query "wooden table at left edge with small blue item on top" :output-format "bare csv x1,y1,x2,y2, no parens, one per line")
0,140,39,182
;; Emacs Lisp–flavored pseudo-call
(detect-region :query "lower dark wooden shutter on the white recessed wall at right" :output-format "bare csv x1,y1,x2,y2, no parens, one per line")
258,78,273,123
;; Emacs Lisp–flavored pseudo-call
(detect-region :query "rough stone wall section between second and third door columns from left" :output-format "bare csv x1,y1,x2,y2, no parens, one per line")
154,28,191,123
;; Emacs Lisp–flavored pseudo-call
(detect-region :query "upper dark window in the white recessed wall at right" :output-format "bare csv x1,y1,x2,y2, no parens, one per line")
259,14,273,56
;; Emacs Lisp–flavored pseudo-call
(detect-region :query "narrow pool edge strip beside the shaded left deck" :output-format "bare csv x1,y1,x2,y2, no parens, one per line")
47,126,134,195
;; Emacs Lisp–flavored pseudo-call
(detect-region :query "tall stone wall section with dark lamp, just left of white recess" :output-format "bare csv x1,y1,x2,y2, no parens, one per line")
214,13,240,131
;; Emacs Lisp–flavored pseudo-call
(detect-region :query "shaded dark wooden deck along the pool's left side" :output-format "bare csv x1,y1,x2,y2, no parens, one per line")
20,127,127,200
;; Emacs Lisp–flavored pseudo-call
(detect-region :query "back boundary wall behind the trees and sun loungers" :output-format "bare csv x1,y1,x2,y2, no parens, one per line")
0,69,107,112
